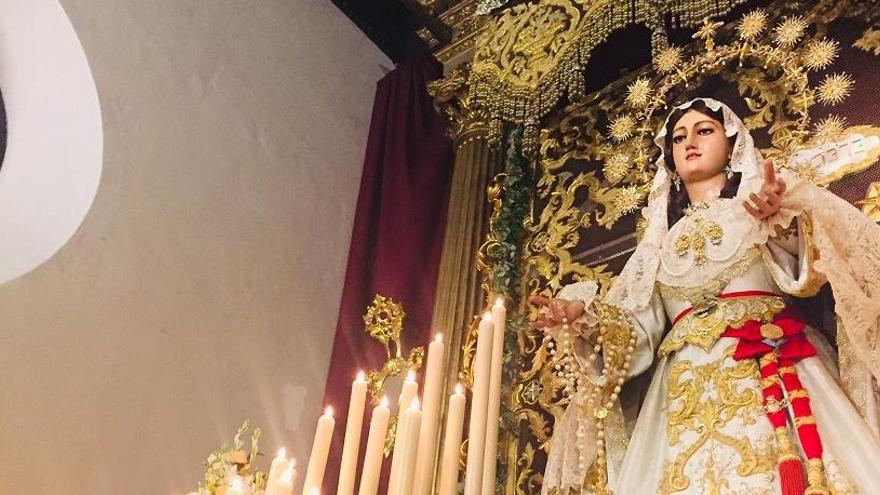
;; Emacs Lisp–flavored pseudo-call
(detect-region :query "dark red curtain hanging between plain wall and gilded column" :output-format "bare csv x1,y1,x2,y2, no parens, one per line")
321,55,452,493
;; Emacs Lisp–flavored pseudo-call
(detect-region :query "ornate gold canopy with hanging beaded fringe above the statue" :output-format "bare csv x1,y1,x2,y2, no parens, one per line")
470,0,745,151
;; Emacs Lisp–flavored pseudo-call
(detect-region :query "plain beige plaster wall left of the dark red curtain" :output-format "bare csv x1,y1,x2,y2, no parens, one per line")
0,0,390,495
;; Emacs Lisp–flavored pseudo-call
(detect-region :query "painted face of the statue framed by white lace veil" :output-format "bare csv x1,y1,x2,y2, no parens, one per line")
672,110,730,184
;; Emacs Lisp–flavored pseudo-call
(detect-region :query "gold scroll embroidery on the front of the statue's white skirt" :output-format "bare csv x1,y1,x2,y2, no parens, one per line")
658,346,777,494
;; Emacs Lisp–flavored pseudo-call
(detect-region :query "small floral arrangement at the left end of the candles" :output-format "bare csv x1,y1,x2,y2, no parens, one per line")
188,420,267,495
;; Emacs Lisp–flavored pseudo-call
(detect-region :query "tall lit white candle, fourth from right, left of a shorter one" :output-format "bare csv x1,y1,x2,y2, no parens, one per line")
412,333,445,495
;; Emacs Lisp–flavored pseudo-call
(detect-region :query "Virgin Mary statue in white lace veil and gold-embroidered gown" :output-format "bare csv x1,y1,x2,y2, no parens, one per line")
532,98,880,495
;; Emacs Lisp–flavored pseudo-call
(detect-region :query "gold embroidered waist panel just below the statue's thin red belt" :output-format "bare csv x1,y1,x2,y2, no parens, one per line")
657,296,785,357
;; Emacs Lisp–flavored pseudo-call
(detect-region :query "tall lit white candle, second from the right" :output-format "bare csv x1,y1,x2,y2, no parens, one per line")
464,312,494,495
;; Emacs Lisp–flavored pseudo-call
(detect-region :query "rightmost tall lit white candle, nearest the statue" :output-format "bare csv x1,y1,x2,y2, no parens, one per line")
481,297,507,495
